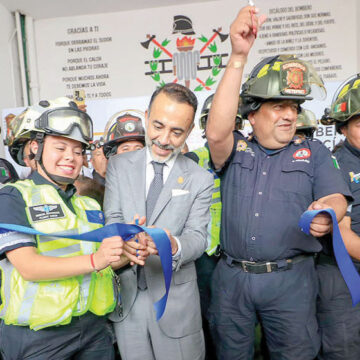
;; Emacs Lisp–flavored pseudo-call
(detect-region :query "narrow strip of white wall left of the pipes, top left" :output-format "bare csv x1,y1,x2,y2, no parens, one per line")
0,4,22,157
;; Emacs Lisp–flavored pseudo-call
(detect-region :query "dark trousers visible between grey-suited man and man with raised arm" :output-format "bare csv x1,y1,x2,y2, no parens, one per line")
195,253,219,360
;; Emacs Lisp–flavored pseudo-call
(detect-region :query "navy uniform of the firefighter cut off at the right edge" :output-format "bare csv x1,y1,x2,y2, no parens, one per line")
317,140,360,360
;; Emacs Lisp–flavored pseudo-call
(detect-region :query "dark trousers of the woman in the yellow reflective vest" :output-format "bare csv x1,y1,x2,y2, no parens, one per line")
0,313,114,360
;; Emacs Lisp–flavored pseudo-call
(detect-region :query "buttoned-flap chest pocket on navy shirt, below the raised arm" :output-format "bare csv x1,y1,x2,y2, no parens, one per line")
228,151,256,196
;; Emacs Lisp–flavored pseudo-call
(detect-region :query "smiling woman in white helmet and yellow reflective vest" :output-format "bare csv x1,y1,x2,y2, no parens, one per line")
0,98,131,360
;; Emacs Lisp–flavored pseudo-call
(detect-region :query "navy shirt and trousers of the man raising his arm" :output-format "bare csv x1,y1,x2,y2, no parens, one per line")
210,132,351,360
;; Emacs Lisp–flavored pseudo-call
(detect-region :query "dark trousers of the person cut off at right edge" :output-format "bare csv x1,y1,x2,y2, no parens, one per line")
317,257,360,360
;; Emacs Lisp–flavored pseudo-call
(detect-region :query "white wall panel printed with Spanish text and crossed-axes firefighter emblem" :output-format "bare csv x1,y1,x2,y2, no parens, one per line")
35,0,359,99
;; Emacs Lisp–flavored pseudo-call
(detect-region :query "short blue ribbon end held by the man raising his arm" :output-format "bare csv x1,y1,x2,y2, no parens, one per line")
299,209,360,306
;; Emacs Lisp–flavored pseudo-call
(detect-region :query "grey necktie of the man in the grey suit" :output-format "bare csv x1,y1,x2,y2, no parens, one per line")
137,161,165,290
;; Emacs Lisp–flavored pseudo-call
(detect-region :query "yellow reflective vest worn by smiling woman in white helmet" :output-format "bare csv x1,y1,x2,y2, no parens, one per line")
0,180,116,330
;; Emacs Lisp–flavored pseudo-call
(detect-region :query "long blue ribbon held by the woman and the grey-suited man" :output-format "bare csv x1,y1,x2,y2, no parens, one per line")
0,223,172,321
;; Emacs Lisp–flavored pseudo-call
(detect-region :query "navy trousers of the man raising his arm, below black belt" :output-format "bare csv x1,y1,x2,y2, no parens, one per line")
209,258,320,360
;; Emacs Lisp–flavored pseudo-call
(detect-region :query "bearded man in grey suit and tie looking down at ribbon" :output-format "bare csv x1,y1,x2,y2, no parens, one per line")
104,84,213,360
